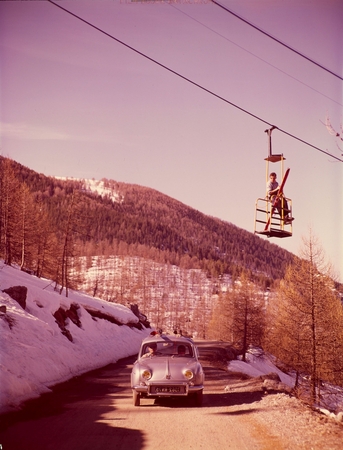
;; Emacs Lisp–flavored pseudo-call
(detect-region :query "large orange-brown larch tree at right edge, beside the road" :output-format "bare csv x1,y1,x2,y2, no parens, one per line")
266,233,343,403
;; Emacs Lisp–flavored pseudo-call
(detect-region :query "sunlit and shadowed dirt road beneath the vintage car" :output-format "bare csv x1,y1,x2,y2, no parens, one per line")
0,343,342,450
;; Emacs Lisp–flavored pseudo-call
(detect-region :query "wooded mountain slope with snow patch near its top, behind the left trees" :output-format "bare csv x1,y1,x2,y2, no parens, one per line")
0,157,294,286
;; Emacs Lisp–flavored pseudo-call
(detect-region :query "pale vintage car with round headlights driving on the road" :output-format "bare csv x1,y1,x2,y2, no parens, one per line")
131,334,205,406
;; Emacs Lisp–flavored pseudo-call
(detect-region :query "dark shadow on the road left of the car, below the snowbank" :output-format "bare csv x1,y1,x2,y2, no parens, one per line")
0,358,144,450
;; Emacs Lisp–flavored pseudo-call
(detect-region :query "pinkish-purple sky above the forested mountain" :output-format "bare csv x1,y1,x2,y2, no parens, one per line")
0,0,343,281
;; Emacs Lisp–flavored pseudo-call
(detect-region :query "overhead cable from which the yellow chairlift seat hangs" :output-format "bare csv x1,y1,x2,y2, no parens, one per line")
46,0,343,162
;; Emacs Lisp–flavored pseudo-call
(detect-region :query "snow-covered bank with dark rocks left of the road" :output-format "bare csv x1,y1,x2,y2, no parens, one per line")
0,260,151,414
